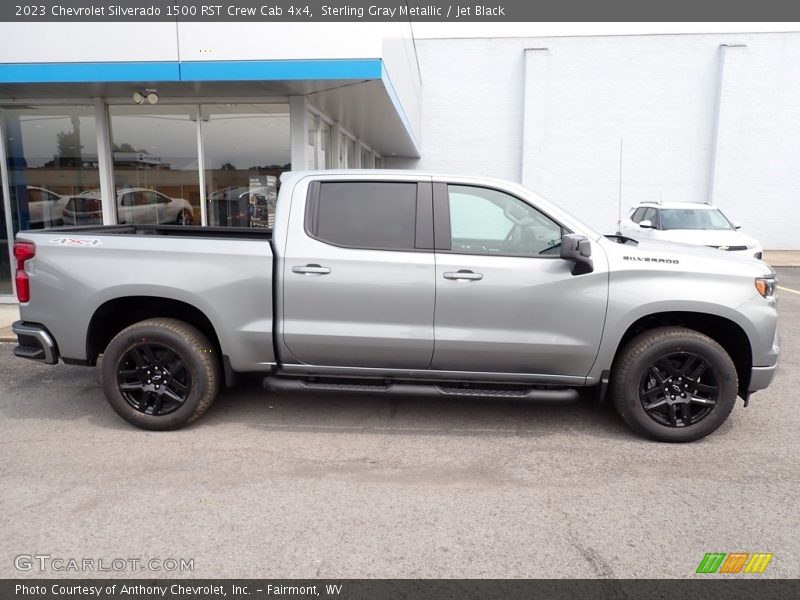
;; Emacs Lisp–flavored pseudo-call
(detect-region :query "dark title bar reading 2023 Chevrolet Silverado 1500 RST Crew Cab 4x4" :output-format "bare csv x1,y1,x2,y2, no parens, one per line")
0,0,800,23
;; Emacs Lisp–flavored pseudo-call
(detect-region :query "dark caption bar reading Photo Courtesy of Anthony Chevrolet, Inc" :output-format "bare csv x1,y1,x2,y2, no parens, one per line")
0,575,800,600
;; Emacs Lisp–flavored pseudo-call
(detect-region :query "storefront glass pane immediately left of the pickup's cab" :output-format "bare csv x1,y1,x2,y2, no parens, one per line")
201,104,291,228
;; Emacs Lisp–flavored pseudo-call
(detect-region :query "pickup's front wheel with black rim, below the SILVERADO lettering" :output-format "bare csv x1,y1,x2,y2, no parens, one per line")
611,327,738,442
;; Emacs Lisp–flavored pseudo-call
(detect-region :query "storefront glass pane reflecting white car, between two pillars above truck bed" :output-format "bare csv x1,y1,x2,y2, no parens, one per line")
108,104,200,225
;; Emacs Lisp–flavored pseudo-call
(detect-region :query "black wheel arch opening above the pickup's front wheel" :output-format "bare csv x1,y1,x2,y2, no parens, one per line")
612,311,753,398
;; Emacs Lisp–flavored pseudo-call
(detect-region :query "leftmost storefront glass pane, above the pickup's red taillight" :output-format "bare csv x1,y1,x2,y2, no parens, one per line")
3,106,100,233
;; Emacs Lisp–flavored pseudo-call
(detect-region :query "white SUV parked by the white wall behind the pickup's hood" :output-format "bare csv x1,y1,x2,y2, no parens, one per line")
620,202,762,258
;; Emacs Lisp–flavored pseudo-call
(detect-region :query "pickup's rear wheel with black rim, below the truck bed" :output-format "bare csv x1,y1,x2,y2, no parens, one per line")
102,318,220,431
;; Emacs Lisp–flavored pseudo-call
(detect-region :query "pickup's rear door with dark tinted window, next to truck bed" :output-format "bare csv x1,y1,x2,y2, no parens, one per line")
282,176,435,369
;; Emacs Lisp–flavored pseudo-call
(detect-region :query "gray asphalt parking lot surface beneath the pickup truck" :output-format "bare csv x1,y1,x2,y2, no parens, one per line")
0,268,800,578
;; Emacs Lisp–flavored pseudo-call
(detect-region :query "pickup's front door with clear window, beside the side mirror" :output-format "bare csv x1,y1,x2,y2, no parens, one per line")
432,183,608,377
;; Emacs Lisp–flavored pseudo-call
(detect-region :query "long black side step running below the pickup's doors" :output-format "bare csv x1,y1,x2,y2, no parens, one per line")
264,375,578,402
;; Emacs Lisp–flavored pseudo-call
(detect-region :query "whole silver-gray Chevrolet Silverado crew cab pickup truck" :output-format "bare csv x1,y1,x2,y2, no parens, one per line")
13,171,779,442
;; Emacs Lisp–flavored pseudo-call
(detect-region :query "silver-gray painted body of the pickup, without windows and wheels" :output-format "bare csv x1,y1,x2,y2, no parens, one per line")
17,171,779,391
